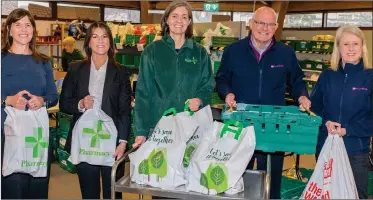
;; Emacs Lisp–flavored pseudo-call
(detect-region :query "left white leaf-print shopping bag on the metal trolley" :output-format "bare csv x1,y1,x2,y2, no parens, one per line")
129,109,197,189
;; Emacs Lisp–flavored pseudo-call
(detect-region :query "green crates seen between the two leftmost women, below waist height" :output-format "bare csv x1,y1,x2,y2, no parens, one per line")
57,112,76,173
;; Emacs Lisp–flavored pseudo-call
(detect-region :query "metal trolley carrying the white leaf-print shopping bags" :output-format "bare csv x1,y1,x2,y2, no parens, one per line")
111,149,271,200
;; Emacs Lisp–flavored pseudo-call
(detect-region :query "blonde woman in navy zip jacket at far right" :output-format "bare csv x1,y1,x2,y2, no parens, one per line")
311,25,373,199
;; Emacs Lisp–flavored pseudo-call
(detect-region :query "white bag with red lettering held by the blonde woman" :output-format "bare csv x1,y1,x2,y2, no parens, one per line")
301,135,359,199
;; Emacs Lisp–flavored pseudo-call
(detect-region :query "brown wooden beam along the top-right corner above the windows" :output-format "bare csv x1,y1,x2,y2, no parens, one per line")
288,1,373,12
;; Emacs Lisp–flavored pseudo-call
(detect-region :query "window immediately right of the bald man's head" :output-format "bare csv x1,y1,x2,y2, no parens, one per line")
284,13,322,28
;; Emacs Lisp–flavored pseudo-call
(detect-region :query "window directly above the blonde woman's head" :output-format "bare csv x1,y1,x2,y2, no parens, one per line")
325,12,373,27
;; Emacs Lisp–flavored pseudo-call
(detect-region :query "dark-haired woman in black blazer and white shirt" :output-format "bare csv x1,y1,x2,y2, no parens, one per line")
60,22,131,199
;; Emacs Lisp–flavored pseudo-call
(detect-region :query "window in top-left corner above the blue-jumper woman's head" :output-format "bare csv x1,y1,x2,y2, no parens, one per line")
1,1,52,17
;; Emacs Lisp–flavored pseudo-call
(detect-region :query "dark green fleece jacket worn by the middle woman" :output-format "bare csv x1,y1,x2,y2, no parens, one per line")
134,35,214,136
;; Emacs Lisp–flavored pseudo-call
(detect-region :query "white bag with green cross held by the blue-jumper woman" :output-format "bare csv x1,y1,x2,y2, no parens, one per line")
2,106,49,177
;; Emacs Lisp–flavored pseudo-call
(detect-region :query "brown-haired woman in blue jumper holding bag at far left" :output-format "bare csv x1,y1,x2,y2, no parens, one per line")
1,9,58,199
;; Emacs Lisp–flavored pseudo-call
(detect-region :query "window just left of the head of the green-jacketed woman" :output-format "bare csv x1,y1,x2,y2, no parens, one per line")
104,7,140,23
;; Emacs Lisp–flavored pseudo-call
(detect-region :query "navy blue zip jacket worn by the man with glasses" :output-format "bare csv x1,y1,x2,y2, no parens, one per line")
215,35,308,105
